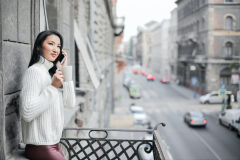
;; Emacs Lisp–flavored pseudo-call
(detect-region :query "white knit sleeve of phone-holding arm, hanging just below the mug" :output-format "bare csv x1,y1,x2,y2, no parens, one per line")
63,81,76,108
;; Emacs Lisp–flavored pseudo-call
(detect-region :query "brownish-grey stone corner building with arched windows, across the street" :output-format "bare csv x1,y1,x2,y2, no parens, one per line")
176,0,240,94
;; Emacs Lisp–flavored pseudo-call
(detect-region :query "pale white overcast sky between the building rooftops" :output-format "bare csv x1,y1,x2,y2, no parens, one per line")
117,0,177,42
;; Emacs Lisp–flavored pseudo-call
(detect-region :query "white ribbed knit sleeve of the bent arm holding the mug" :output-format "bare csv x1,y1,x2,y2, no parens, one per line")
20,68,58,122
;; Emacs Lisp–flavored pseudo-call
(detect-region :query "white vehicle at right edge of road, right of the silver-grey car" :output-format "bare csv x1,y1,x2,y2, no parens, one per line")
218,109,240,130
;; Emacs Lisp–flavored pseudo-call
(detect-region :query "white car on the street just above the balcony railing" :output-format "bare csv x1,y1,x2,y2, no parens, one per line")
130,106,148,125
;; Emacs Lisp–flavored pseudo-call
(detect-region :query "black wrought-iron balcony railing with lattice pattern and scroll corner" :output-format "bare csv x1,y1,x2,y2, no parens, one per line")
60,123,170,160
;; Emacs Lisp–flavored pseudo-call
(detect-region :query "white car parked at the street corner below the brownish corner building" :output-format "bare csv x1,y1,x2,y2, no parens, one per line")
199,91,232,104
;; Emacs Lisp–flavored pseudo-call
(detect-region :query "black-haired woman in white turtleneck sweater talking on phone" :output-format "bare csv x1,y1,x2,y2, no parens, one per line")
20,30,75,160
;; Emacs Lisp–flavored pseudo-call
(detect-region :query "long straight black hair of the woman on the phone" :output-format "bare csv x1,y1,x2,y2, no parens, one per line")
28,30,63,76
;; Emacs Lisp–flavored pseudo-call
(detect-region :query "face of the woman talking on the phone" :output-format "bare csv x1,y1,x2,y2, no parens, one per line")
42,34,61,62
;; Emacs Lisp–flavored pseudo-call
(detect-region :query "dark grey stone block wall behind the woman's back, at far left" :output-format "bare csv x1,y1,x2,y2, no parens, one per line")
0,0,36,159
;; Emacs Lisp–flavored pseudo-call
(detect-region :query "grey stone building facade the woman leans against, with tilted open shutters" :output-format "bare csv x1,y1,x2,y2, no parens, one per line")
0,0,120,159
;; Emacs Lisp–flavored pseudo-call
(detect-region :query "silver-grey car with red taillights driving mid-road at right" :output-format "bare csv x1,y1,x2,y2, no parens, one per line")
184,111,207,127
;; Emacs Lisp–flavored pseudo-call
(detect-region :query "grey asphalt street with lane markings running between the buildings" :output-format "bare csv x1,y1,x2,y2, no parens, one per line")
112,68,240,160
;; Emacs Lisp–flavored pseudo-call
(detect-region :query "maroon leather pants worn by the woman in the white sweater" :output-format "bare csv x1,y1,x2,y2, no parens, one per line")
25,143,66,160
